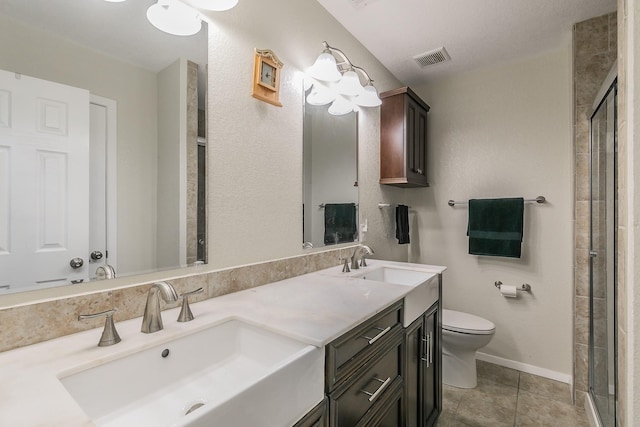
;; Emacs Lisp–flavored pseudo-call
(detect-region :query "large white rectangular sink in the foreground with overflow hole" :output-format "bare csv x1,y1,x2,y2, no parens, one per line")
60,320,324,427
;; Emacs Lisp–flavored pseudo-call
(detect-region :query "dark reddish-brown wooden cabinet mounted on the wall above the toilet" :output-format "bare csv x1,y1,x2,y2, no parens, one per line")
380,87,430,187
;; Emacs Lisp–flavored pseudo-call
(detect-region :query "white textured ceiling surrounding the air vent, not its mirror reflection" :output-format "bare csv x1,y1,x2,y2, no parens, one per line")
318,0,617,86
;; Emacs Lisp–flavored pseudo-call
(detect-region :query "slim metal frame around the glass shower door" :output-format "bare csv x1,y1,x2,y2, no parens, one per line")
588,73,618,426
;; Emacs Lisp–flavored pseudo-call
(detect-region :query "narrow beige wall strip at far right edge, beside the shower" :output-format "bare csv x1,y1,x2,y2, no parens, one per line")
617,0,640,427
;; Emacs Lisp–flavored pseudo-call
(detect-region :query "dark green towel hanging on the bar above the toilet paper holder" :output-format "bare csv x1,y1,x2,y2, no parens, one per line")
467,197,524,258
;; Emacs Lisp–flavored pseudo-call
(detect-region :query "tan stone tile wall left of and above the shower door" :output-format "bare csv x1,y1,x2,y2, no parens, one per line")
573,12,617,405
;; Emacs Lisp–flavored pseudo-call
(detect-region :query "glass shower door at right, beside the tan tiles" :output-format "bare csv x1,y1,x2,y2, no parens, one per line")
589,80,618,427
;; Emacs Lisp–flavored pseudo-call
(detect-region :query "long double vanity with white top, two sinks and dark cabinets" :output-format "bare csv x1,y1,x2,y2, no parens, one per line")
0,260,445,427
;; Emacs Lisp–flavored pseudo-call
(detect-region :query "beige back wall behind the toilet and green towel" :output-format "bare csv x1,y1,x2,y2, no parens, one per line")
410,46,573,382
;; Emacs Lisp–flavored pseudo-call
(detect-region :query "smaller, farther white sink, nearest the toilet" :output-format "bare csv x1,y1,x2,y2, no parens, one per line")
351,265,440,327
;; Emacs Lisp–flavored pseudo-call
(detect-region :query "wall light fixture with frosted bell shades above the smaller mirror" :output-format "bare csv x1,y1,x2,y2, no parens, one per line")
307,41,382,115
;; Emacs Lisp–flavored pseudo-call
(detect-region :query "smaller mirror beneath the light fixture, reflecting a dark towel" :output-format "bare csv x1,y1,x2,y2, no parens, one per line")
303,98,358,248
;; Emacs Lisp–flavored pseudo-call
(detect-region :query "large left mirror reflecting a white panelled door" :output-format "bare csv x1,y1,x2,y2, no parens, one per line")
0,0,207,293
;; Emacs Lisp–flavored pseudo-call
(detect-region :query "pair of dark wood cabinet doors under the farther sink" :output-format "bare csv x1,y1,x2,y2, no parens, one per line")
403,302,442,427
